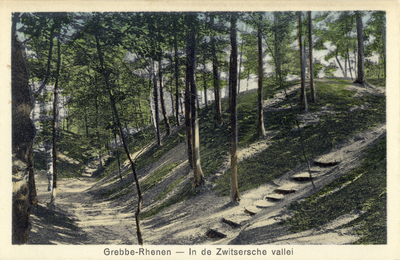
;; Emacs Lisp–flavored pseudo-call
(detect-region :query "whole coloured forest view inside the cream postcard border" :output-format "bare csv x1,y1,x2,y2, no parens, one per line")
11,11,387,245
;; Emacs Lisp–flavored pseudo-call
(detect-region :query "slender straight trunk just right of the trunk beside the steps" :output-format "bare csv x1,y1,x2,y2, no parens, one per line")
257,20,265,137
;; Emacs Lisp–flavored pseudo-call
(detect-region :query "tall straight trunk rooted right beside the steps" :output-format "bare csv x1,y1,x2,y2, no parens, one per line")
229,14,240,202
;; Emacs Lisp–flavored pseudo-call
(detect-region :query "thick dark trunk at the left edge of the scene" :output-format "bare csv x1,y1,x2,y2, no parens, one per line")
11,35,37,244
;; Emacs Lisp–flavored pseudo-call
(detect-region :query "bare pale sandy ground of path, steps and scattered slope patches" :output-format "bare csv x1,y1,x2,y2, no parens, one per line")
30,80,386,245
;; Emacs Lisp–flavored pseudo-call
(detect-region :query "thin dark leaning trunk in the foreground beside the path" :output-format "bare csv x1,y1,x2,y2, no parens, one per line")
95,35,143,245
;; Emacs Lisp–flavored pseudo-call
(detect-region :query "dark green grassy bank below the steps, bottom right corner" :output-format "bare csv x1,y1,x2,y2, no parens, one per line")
282,138,387,244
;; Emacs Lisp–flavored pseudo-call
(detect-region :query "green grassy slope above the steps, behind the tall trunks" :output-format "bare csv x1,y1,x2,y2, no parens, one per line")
138,80,385,221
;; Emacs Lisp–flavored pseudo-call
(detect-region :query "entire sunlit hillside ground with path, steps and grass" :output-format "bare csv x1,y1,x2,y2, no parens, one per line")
30,78,386,245
